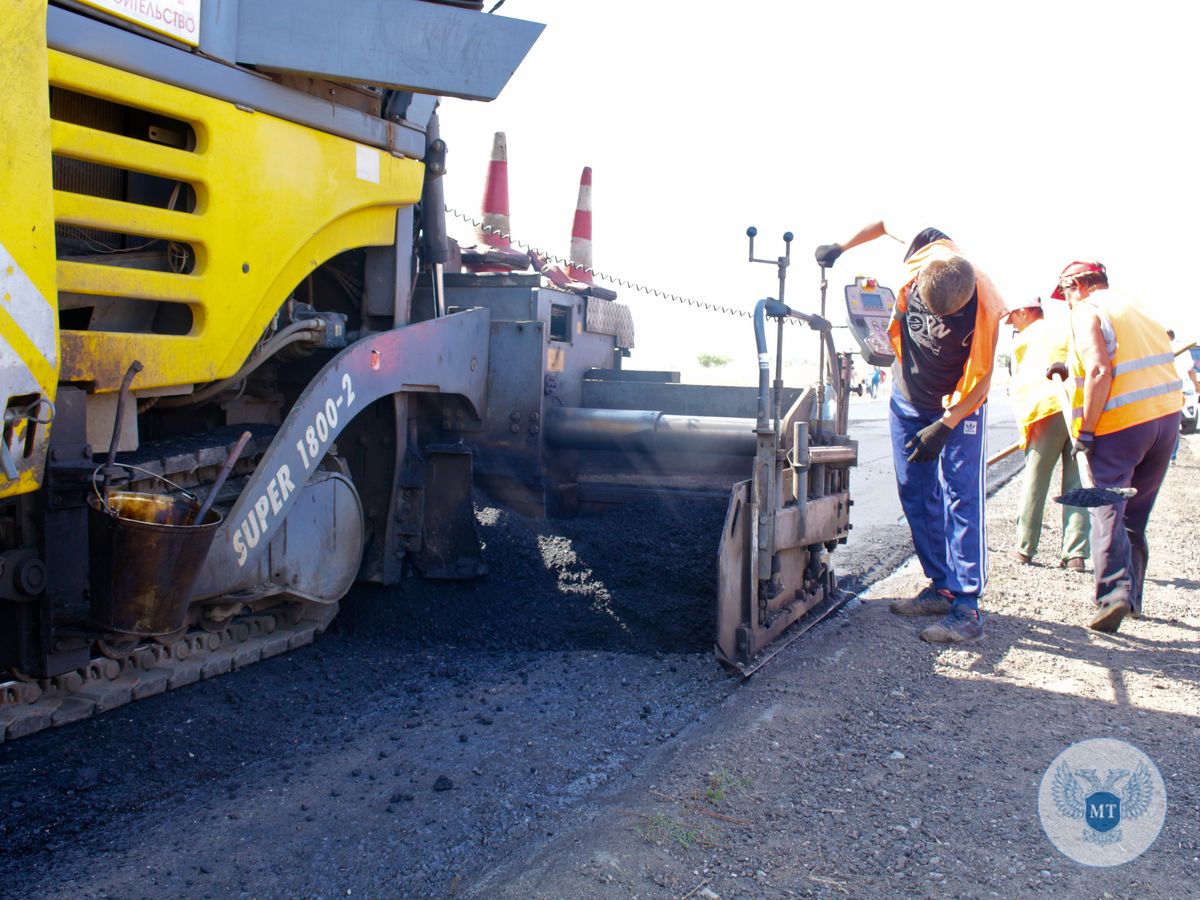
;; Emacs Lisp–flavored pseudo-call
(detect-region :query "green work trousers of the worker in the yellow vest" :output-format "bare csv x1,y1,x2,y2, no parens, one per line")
1016,415,1088,560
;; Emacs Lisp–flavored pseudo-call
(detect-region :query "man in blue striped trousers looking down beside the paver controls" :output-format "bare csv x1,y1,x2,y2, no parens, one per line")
816,222,1006,643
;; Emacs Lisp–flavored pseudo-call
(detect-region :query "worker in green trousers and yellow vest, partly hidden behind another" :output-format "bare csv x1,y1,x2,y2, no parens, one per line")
1008,298,1087,571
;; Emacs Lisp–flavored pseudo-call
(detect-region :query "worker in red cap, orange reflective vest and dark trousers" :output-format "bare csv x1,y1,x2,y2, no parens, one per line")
1051,260,1183,632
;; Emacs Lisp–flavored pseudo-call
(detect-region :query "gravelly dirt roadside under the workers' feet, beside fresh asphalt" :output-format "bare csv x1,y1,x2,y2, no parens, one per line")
475,436,1200,900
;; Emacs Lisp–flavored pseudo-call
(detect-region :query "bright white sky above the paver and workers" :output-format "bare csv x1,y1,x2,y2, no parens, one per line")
442,0,1200,382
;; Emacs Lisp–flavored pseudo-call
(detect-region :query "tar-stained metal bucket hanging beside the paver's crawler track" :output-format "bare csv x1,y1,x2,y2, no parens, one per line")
88,491,222,635
